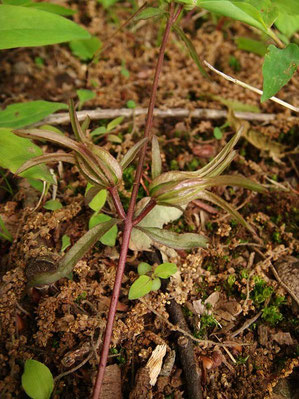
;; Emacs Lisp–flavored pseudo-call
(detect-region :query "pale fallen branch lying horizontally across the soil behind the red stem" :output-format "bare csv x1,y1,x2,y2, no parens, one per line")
35,108,288,126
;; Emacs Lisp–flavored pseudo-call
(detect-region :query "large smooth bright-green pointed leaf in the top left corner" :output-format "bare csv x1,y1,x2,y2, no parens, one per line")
0,4,90,50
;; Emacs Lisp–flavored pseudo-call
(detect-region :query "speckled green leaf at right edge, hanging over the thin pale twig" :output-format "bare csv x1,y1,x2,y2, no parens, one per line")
261,43,299,102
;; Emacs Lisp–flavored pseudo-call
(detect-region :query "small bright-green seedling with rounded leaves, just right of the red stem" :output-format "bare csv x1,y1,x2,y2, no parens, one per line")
129,262,178,299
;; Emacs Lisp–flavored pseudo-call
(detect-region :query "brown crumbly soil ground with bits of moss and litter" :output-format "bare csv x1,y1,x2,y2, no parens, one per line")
0,0,299,399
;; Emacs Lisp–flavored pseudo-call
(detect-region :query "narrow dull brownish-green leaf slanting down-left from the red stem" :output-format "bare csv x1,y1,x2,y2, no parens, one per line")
29,219,120,287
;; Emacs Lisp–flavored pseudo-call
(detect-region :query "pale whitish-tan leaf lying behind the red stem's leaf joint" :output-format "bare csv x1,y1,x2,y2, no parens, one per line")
130,197,183,251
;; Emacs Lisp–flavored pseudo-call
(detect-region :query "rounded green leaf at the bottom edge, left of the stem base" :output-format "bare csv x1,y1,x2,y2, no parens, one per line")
22,359,54,399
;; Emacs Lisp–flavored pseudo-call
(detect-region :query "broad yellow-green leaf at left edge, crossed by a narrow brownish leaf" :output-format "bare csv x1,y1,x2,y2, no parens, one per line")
0,128,54,184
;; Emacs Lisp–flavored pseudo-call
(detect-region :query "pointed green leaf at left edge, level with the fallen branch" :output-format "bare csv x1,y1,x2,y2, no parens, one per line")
0,101,67,129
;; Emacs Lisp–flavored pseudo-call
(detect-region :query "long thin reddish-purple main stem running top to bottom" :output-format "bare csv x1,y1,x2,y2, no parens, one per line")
92,3,178,399
